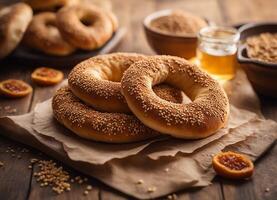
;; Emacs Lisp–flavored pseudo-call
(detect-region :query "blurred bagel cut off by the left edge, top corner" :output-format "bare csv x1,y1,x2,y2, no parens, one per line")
0,3,33,59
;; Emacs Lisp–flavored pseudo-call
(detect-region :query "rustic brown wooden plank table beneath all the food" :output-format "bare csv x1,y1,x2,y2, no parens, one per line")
0,0,277,200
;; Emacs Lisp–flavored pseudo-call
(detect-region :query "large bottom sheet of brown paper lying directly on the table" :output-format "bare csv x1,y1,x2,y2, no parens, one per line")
0,113,277,199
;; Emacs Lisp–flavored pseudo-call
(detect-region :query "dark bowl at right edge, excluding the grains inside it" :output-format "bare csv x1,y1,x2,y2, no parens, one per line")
237,23,277,98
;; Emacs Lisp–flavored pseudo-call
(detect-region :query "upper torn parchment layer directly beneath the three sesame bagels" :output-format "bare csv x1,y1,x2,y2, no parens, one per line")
33,99,257,164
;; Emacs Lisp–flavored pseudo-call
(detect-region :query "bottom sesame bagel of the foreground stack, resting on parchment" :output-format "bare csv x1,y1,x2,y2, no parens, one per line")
52,87,158,143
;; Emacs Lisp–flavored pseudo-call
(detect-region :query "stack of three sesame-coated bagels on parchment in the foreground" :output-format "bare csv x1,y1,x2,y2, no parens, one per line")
52,53,229,143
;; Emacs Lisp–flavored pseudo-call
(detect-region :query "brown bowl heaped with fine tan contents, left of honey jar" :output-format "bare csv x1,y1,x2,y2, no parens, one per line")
143,9,208,59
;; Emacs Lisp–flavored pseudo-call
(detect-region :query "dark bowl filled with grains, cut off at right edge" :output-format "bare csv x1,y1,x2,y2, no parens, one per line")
237,23,277,98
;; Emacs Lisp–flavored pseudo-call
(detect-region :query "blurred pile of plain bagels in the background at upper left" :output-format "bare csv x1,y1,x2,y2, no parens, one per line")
0,0,118,59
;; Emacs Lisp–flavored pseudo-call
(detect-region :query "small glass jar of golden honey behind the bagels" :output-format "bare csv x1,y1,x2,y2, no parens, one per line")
197,26,240,81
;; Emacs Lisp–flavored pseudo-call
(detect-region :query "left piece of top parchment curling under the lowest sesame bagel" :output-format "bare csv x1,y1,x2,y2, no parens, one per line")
32,99,167,164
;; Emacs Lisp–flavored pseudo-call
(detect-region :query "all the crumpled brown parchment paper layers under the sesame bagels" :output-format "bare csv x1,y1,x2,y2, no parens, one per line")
0,71,277,199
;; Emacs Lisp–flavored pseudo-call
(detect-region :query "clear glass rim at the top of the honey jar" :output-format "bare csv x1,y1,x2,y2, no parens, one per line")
198,26,240,44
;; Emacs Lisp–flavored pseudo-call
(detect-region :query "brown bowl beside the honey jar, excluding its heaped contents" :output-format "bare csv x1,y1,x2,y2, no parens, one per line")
143,9,207,59
